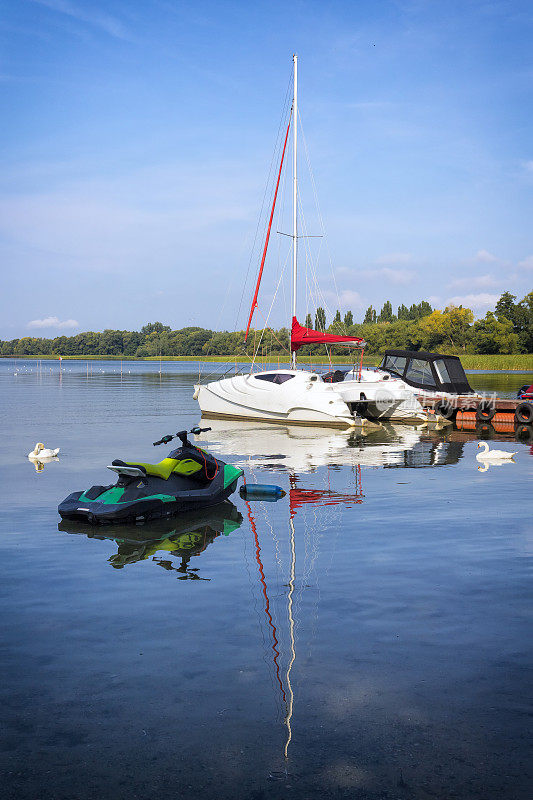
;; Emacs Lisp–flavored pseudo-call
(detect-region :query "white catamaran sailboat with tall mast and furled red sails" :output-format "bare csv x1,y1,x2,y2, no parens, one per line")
194,55,427,428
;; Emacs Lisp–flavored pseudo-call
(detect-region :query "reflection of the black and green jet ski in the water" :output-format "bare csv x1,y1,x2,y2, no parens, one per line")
57,500,242,580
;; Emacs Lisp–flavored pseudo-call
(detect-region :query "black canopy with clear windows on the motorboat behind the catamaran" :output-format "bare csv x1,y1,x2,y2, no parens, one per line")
380,350,474,394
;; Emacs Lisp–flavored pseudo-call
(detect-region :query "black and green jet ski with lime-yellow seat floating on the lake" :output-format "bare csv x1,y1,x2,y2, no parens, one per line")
57,426,243,525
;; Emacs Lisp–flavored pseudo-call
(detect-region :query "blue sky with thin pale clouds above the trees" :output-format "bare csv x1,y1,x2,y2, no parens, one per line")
0,0,533,338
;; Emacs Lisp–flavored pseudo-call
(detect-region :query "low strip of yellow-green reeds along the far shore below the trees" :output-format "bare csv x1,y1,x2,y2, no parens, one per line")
0,353,533,372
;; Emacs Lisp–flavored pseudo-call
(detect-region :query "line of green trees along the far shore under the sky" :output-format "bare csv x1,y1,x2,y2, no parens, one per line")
0,292,533,358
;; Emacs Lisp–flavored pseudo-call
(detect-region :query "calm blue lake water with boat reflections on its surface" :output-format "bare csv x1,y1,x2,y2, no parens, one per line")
0,359,533,800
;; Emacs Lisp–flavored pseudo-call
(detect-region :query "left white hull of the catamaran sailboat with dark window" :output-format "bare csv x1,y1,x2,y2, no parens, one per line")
194,370,355,428
